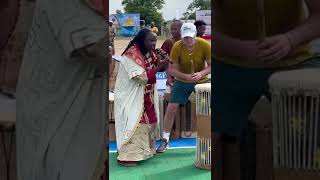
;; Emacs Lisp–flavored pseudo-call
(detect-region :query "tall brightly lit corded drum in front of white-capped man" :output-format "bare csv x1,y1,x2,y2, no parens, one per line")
195,83,211,169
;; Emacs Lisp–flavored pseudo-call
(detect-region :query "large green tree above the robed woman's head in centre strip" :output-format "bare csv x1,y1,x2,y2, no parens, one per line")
122,0,165,26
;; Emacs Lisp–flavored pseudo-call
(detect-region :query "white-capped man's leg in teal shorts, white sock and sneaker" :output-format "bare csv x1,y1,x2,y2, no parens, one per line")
157,81,195,153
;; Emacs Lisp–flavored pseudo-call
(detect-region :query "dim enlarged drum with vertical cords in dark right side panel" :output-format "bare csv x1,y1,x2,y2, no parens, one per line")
269,69,320,180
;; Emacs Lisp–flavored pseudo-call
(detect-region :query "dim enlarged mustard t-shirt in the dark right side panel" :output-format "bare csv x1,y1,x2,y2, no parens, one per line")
213,0,312,68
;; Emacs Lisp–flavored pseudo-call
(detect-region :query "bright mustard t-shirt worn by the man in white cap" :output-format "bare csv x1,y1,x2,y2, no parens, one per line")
170,38,211,83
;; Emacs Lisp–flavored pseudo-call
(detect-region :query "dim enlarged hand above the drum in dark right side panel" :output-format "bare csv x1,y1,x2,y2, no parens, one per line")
257,34,292,64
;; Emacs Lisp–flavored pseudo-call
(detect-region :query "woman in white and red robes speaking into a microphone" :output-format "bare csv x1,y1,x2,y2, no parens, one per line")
114,29,168,166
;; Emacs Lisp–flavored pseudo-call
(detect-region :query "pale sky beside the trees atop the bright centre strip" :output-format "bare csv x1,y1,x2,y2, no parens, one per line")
109,0,193,21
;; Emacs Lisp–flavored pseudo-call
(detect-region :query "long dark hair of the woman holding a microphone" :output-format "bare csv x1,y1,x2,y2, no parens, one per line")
122,29,152,55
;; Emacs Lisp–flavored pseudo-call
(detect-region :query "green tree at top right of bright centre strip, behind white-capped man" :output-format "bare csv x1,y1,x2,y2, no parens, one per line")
183,0,211,19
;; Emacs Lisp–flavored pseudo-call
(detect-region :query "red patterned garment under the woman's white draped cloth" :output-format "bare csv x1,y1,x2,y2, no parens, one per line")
124,44,157,124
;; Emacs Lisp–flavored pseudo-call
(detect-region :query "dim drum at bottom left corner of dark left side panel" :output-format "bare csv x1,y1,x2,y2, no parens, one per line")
0,94,17,180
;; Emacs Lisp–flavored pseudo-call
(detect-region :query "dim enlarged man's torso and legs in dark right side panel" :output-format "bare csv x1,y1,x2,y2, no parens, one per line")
212,0,320,180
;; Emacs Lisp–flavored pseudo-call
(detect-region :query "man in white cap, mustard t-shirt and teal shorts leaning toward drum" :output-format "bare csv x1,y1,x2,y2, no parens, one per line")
157,23,211,153
